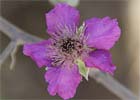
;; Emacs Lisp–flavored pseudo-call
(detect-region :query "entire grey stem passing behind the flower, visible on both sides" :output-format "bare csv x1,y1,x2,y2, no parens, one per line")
0,17,138,100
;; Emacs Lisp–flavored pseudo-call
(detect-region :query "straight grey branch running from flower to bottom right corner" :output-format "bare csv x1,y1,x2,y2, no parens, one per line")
89,69,138,100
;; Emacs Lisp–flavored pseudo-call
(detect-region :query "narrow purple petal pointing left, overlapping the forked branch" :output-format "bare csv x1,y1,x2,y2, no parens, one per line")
23,39,52,67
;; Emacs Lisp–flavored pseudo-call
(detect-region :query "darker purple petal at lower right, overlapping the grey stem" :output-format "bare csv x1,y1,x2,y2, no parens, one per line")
84,50,116,74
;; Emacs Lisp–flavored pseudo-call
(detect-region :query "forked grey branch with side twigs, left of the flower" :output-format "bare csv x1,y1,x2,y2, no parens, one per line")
0,17,42,69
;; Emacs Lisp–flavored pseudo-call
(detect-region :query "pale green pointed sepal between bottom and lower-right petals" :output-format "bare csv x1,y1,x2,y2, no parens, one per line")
76,59,89,80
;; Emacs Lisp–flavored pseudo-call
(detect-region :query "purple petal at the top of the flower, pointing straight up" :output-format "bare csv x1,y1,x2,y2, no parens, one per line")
46,3,80,36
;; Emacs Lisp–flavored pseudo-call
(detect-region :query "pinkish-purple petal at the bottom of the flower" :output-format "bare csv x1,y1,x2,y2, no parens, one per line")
45,64,82,99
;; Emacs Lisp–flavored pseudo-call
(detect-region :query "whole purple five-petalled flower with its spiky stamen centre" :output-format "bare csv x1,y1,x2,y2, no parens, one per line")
23,3,120,99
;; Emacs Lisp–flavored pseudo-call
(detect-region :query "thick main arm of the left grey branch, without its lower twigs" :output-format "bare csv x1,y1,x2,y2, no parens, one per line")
0,17,42,43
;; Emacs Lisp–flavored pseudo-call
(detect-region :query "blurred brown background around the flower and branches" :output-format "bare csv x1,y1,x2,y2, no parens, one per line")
0,0,140,100
